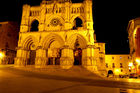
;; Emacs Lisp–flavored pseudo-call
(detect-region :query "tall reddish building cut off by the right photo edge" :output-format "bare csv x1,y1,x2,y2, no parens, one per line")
127,18,140,74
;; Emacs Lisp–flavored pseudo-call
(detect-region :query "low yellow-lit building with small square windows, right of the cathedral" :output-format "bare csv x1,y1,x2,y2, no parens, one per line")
105,54,134,75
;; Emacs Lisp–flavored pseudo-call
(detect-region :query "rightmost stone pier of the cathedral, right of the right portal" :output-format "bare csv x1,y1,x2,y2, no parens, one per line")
82,45,97,72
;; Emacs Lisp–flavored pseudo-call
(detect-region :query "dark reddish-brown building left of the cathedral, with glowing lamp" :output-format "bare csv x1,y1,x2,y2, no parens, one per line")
0,21,18,64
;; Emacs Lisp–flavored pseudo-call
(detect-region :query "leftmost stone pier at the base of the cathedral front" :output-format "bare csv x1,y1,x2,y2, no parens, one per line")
14,47,29,66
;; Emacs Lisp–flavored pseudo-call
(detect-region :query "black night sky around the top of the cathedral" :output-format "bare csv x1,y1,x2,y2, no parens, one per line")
0,0,140,54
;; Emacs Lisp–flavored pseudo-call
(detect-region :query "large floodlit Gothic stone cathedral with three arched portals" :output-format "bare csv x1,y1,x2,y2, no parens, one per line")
15,0,106,73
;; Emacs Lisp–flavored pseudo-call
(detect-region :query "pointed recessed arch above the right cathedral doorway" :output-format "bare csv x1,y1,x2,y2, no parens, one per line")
67,34,87,48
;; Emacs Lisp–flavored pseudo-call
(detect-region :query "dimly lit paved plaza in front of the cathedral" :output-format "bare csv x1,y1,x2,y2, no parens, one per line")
0,65,140,93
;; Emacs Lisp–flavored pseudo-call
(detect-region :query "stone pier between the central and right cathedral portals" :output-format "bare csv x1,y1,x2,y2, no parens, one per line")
60,45,74,69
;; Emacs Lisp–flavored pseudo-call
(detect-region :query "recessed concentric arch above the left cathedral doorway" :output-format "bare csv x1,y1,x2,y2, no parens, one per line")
22,36,38,50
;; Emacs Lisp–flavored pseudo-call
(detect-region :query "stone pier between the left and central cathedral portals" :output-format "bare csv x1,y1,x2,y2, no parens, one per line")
35,46,48,68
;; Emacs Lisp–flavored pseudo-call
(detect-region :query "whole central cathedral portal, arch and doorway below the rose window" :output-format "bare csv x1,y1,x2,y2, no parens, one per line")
42,34,64,65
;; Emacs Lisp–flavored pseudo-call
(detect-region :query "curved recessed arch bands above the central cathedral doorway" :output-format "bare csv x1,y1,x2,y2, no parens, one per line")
41,34,64,49
